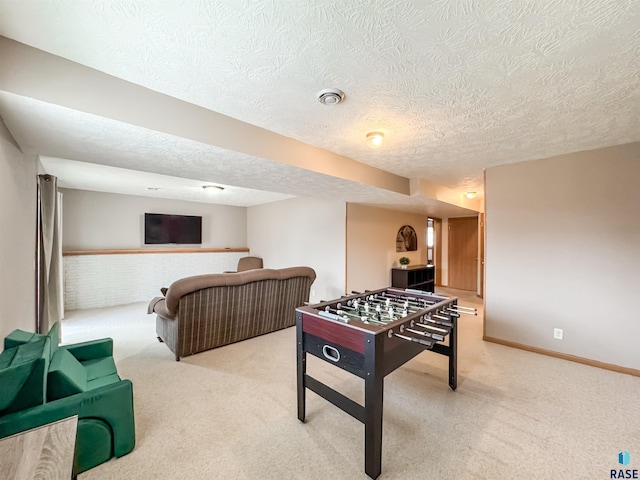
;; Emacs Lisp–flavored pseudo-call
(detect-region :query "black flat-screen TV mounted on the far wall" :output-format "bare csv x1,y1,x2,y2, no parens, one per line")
144,213,202,245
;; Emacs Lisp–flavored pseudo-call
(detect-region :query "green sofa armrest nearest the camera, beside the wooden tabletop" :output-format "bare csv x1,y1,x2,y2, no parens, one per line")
0,380,135,457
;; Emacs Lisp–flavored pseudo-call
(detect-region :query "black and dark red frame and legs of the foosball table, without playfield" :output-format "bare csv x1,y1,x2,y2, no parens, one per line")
296,288,464,479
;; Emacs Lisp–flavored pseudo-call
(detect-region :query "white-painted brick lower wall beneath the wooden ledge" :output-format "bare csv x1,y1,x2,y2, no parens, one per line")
63,252,247,311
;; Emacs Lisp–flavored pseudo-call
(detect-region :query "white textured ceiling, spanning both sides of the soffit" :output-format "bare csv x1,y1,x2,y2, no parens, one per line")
0,0,640,216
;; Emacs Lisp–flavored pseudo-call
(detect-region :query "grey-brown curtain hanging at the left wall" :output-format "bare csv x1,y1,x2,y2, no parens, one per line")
36,175,62,333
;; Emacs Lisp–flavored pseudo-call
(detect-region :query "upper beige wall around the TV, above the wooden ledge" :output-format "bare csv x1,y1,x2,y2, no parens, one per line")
61,189,247,250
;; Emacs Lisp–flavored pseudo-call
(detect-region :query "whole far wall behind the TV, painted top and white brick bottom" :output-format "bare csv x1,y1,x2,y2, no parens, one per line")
61,189,247,310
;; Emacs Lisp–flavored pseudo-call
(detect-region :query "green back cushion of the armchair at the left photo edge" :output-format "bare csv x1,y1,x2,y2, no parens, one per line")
0,337,50,414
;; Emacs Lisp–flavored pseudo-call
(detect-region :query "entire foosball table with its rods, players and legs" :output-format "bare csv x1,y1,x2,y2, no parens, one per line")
296,288,475,479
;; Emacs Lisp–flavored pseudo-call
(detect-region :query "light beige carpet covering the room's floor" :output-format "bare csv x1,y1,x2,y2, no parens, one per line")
62,291,640,480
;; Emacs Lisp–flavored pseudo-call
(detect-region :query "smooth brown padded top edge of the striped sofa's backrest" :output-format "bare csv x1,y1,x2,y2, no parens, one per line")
165,267,316,316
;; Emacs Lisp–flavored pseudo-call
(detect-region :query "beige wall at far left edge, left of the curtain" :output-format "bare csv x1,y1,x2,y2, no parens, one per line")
0,120,39,342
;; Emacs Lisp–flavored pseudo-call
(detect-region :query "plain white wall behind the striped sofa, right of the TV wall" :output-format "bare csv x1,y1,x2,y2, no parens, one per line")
247,198,346,302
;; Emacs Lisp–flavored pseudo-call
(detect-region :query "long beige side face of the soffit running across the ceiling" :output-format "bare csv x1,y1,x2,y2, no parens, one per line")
0,38,476,215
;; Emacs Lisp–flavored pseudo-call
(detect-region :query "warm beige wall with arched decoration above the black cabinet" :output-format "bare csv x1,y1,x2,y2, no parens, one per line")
347,203,427,292
